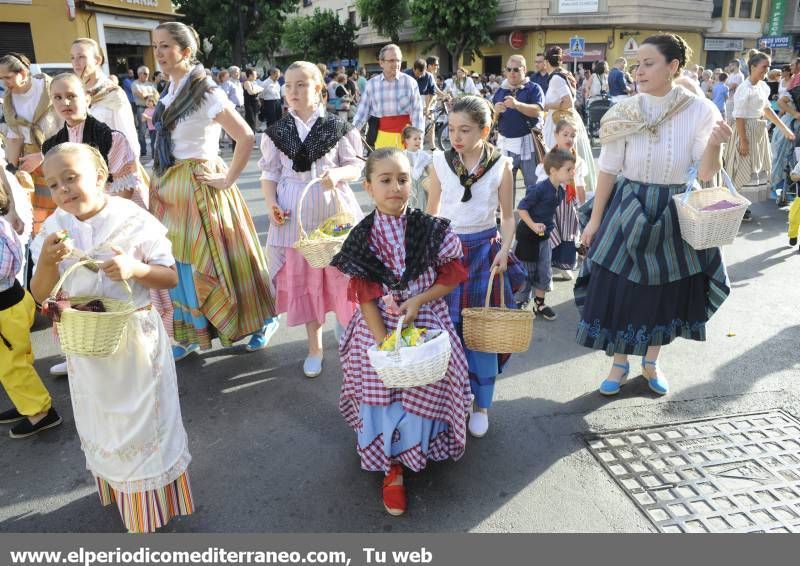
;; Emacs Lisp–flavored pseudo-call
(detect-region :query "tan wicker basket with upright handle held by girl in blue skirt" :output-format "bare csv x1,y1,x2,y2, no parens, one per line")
461,268,534,354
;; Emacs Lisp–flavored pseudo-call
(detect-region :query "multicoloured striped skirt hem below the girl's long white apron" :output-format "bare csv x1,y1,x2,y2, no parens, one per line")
95,472,194,533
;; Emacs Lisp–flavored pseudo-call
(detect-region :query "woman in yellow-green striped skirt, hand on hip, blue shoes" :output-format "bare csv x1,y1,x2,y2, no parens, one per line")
150,22,278,360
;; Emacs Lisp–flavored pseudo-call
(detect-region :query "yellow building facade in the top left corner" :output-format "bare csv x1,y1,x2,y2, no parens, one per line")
0,0,176,73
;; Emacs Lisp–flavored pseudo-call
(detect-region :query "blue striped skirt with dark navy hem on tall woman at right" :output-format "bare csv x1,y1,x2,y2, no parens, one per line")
575,178,730,355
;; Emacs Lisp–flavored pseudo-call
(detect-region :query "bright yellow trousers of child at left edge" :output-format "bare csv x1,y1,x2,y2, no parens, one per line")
0,291,51,416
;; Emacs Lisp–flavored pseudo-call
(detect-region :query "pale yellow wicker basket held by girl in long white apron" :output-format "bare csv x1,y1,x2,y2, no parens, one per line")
50,260,136,358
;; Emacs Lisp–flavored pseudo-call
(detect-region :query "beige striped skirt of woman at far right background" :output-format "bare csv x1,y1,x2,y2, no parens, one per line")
723,118,772,190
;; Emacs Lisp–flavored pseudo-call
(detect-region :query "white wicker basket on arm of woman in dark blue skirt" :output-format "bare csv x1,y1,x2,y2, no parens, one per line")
672,171,750,250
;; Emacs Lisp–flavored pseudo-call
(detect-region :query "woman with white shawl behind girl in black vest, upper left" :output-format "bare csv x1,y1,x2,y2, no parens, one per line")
69,37,141,161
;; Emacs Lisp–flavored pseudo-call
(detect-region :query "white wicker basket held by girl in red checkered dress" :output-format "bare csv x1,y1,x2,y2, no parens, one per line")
367,316,452,389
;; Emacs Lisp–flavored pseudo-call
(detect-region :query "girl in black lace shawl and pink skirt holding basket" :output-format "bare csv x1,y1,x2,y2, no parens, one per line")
259,61,363,377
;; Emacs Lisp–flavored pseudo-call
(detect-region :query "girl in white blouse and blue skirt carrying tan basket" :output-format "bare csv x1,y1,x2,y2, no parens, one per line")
428,96,525,437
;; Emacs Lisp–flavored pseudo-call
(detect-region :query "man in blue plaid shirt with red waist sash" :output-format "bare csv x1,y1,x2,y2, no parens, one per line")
353,43,425,149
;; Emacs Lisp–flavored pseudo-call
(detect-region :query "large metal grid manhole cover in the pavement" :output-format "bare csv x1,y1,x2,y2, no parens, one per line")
584,410,800,533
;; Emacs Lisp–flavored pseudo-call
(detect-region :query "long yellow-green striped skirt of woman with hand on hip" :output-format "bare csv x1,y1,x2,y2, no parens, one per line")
150,158,275,349
